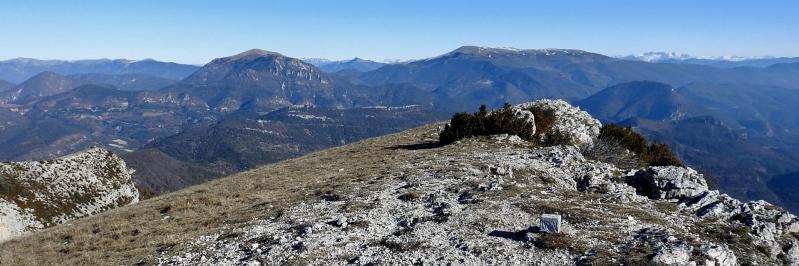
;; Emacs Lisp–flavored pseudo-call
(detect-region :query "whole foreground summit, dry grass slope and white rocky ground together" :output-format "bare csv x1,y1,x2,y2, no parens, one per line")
0,101,799,265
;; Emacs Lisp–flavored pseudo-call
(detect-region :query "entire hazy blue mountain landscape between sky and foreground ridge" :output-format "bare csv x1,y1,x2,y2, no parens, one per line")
0,46,799,212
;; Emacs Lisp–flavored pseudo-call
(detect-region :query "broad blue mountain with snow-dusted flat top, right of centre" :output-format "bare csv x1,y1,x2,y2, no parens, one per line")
360,46,615,110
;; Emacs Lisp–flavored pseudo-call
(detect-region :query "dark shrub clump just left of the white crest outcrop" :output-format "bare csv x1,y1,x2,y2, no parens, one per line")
438,103,535,144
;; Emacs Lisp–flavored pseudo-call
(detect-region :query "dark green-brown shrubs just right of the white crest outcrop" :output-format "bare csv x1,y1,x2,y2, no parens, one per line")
587,124,683,168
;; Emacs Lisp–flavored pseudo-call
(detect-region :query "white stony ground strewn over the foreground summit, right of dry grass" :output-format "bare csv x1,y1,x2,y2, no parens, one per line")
158,103,799,265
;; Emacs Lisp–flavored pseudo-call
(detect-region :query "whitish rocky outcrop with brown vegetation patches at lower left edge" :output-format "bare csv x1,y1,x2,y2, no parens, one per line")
0,148,139,241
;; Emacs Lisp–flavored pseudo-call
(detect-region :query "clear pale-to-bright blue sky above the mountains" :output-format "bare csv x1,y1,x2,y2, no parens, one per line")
0,0,799,64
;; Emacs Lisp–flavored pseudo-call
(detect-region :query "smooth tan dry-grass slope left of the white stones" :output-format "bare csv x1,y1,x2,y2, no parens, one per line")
0,125,442,265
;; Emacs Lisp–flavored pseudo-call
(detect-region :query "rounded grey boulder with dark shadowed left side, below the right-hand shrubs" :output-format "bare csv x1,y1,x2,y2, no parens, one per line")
627,166,708,200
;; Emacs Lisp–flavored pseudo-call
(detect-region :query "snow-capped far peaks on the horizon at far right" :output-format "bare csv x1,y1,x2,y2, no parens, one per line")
619,52,799,68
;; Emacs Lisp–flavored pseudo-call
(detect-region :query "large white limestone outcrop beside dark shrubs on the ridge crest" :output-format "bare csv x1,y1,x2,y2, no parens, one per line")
514,99,602,146
